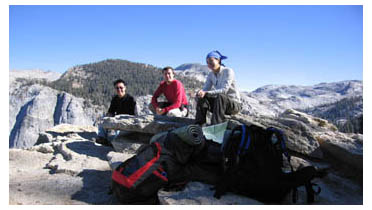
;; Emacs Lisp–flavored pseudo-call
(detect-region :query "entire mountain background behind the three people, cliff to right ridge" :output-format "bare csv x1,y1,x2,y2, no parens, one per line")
9,60,363,147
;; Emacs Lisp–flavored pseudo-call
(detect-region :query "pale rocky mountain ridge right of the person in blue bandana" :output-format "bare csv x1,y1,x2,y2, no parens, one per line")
243,80,363,133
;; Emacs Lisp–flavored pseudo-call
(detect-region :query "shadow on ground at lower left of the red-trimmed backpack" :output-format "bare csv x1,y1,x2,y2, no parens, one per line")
71,169,120,205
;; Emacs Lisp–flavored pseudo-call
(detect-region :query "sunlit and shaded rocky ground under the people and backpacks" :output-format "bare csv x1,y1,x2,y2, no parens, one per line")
9,110,363,205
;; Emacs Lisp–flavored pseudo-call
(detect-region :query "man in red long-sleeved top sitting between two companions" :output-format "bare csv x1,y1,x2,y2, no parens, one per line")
149,66,188,117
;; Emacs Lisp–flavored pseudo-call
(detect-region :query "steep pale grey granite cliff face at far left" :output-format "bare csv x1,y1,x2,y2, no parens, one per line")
9,83,103,148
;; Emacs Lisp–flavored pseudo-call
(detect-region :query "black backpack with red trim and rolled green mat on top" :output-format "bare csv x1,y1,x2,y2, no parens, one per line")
111,131,209,204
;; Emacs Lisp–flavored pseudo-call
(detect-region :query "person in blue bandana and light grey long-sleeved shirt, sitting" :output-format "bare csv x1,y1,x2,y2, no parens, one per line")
195,51,242,125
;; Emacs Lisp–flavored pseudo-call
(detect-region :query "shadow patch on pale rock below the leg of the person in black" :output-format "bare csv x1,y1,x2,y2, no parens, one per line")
66,141,113,161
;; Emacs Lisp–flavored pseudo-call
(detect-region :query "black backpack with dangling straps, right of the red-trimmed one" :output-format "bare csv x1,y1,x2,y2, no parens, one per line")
214,124,324,203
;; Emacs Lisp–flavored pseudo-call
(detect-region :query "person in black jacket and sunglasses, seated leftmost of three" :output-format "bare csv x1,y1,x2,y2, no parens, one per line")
96,79,136,146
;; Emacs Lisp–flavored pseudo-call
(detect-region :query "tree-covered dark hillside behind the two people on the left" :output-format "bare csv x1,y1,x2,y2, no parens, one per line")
46,59,202,108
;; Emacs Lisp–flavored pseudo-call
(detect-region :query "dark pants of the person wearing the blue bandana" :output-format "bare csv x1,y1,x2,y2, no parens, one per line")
195,94,242,125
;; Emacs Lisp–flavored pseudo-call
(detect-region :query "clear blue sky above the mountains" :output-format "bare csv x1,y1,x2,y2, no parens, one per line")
9,5,363,90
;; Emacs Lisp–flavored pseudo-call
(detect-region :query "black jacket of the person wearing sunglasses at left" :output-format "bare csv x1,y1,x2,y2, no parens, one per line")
108,94,136,116
